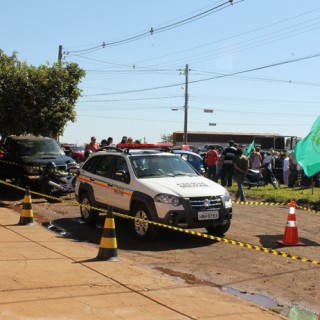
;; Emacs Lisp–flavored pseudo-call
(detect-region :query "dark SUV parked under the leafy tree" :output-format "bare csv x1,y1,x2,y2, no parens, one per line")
0,136,76,186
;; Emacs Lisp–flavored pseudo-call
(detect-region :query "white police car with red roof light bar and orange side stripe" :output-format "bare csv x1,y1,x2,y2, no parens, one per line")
75,148,232,240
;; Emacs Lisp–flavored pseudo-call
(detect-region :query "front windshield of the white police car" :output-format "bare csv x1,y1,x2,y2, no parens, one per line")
130,154,199,178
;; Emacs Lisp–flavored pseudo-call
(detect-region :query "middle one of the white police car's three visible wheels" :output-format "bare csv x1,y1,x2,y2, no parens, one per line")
131,204,159,241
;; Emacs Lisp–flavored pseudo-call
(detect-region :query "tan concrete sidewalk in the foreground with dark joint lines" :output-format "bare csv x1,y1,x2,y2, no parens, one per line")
0,208,286,320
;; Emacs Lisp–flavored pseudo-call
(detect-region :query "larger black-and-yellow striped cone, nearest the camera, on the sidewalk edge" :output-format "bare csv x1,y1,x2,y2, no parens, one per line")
97,207,119,261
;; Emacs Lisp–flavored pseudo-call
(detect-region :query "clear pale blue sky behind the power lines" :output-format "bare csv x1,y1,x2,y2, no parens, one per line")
0,0,320,144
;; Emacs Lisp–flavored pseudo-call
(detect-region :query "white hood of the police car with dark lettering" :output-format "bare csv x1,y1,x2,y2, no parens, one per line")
140,176,225,197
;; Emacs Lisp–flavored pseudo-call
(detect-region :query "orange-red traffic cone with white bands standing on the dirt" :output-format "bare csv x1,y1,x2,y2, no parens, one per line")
277,200,304,246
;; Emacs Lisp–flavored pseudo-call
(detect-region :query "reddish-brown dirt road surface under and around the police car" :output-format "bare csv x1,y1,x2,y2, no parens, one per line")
0,187,320,315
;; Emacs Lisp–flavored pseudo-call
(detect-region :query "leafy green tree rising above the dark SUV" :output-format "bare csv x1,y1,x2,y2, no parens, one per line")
0,50,85,137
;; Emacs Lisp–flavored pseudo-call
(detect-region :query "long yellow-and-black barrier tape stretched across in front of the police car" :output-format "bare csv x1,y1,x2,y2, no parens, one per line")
0,179,320,265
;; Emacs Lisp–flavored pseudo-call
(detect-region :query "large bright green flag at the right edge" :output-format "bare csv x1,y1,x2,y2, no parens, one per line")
293,116,320,177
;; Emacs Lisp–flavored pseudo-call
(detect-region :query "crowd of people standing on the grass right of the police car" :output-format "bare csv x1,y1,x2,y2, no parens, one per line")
204,140,319,201
